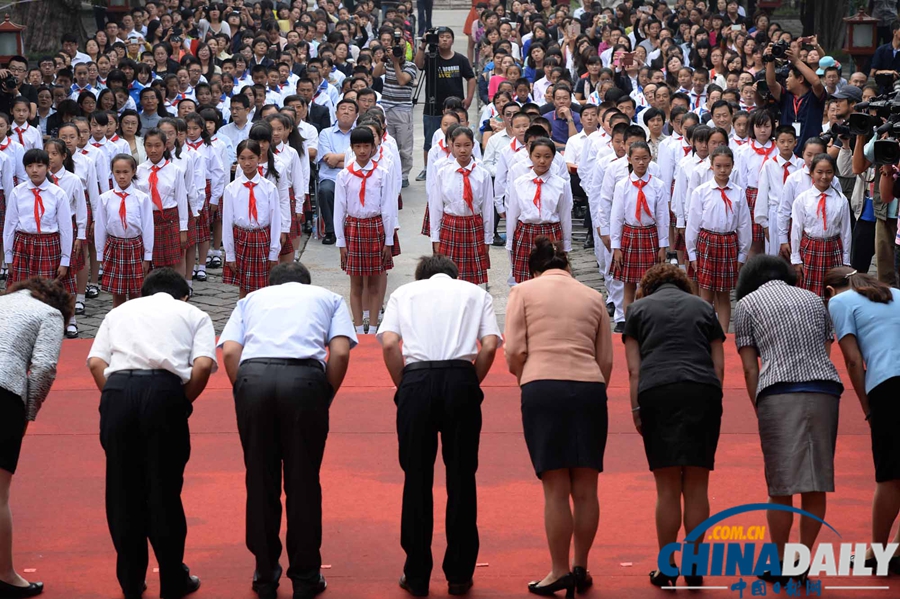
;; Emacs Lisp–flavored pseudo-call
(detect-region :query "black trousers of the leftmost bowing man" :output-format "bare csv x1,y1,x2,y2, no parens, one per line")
100,370,192,598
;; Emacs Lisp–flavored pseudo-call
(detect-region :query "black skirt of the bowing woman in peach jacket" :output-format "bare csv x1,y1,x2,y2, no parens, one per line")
522,381,609,478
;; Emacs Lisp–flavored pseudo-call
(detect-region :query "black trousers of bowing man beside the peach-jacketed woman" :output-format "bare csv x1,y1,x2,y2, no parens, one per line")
395,361,484,589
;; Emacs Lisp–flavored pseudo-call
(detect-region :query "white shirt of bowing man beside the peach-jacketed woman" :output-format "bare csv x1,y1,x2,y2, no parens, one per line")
377,274,502,364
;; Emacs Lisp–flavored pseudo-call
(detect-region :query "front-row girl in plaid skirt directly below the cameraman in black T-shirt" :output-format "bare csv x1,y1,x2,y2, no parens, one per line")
428,127,494,285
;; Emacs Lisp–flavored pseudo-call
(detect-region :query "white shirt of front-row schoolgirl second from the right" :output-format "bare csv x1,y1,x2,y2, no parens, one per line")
684,179,753,262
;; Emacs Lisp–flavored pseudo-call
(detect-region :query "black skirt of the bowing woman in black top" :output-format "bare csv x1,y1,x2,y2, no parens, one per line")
638,383,722,470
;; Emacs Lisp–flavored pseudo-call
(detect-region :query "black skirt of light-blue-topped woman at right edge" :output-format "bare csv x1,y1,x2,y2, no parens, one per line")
869,377,900,483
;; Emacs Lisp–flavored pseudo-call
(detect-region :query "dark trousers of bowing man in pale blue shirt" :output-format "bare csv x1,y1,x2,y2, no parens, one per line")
234,359,333,590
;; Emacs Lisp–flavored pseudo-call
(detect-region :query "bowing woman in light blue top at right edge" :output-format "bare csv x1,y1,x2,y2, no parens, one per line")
825,266,900,574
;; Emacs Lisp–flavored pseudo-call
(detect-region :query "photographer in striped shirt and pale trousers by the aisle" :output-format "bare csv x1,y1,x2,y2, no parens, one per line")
372,26,419,187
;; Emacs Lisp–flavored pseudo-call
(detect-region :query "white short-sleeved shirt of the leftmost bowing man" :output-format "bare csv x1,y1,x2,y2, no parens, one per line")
88,293,217,383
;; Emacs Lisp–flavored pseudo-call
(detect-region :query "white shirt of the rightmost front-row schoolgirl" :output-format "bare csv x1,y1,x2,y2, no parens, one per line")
791,187,850,265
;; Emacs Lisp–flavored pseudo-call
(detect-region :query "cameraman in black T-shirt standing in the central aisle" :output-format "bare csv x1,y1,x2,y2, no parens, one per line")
415,27,477,181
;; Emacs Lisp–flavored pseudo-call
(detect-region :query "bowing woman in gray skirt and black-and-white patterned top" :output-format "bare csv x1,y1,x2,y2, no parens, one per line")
734,254,844,580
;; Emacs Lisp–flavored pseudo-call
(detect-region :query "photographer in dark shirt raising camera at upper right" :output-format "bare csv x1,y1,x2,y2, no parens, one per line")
763,42,825,151
